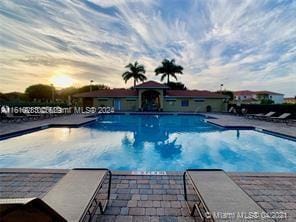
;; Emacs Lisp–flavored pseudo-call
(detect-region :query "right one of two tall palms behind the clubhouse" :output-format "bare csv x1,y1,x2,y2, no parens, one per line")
154,59,183,83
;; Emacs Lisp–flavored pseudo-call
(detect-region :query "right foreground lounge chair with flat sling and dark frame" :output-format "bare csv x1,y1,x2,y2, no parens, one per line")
183,169,272,222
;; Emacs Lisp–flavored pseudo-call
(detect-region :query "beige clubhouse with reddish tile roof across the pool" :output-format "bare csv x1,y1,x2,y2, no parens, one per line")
73,81,227,112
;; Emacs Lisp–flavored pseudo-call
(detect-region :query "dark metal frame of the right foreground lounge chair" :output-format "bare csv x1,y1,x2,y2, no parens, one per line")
183,169,223,222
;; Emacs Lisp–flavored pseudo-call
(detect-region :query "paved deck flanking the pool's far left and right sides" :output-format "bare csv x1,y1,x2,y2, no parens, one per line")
0,113,296,138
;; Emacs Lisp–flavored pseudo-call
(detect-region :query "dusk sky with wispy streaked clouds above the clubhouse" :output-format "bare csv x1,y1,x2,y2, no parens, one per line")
0,0,296,96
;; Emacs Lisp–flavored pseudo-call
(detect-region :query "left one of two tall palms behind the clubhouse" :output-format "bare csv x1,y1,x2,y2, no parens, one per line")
122,61,147,88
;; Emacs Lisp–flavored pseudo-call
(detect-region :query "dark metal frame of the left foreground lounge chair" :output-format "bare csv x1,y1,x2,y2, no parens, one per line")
73,168,112,222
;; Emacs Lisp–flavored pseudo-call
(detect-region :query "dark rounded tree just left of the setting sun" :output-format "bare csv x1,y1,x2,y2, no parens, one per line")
25,84,55,101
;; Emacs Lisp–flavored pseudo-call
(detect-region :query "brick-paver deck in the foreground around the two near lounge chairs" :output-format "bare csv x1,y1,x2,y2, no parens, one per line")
0,169,296,222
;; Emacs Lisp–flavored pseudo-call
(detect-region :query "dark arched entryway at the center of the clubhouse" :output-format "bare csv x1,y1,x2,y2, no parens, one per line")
141,90,160,112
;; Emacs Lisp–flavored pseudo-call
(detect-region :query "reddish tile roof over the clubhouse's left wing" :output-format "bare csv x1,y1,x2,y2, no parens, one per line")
73,89,138,98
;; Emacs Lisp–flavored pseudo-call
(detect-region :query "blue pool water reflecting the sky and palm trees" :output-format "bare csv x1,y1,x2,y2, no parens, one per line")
0,115,296,172
